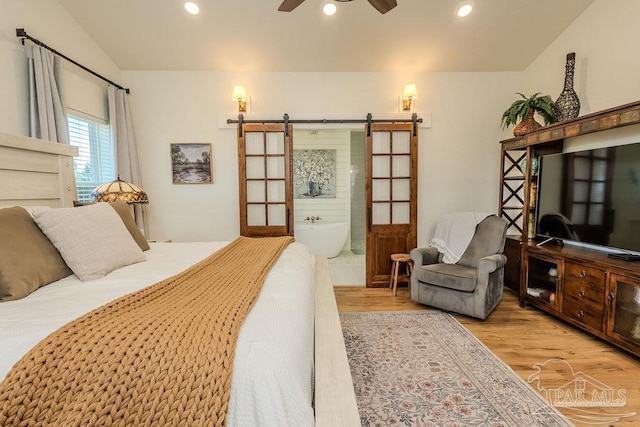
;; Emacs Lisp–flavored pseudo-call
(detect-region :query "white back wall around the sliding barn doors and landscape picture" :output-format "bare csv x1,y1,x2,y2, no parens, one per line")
123,71,521,245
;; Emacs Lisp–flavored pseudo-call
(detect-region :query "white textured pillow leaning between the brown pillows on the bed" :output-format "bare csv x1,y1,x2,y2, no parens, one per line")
33,203,145,281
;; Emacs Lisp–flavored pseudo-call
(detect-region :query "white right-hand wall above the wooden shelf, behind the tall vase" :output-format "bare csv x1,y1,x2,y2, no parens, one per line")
525,0,640,115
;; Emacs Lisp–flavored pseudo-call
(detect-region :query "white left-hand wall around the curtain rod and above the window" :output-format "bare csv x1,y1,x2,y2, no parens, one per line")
0,0,120,136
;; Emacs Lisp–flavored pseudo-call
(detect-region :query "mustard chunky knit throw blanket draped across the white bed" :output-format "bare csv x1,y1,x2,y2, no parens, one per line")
0,237,293,426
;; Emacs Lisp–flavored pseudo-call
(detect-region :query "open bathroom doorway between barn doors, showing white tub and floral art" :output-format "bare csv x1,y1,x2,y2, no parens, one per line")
293,128,366,286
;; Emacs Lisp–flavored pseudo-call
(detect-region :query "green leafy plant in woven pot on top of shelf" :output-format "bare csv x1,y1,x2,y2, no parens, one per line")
502,92,553,136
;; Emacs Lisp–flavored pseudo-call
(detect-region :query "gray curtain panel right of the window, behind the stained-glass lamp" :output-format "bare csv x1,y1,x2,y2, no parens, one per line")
107,85,149,238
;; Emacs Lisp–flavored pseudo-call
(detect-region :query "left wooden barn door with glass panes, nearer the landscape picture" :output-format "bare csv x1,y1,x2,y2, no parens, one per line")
238,123,293,236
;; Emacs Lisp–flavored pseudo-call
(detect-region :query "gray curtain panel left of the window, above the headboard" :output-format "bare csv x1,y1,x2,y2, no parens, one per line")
27,44,69,144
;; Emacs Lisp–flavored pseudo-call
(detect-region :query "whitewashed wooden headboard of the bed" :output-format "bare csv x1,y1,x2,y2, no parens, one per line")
0,133,78,208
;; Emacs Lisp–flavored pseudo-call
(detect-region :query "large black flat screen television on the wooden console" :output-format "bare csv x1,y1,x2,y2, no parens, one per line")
536,143,640,254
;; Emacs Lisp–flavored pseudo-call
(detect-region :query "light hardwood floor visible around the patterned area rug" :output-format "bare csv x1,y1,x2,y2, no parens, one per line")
334,286,640,426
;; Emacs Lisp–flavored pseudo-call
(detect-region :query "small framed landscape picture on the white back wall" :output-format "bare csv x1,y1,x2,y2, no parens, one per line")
171,144,213,184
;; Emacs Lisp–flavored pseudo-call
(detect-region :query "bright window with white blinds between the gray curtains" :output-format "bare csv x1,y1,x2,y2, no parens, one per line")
68,114,116,202
